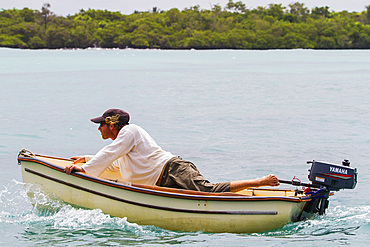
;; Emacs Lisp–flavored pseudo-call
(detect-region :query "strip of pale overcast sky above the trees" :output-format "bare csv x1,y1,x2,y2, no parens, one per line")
0,0,370,16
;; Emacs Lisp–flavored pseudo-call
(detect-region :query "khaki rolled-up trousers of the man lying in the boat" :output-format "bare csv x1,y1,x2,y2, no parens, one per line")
159,157,230,192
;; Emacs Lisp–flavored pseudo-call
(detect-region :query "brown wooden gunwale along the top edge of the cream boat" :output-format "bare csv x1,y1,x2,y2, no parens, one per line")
17,155,312,203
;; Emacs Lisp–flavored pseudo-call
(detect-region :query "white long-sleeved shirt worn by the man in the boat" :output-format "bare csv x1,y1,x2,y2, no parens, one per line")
82,124,174,185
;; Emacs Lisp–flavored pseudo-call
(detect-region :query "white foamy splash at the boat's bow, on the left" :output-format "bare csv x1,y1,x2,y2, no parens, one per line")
0,180,175,240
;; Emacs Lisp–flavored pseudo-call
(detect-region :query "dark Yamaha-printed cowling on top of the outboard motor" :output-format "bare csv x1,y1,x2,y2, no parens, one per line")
307,160,357,191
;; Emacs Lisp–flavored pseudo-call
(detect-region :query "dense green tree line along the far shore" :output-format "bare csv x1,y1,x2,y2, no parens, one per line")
0,0,370,49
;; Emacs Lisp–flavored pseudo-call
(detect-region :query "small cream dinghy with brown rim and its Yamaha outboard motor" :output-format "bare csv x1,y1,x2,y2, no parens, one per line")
18,149,357,233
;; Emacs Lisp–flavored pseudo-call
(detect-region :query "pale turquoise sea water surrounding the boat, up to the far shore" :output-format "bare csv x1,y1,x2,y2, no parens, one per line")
0,48,370,246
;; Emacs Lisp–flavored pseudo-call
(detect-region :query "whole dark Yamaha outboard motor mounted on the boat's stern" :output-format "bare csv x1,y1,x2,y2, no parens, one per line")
305,160,357,215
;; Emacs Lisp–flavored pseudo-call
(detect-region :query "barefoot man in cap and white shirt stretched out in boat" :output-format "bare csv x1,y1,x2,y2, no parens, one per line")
64,109,279,192
